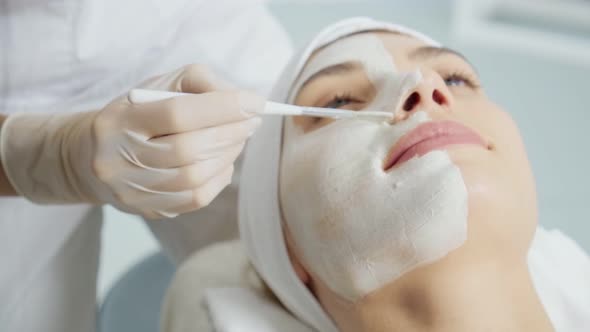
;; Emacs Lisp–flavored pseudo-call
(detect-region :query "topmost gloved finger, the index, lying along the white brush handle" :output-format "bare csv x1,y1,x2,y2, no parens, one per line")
127,91,265,138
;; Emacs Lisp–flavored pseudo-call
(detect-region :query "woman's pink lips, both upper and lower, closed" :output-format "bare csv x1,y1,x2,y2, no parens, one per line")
383,121,488,171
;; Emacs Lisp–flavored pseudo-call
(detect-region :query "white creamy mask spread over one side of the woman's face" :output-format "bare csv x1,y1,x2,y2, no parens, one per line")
280,33,467,301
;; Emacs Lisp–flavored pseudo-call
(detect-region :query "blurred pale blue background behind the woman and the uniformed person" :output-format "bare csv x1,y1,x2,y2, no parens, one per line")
99,0,590,296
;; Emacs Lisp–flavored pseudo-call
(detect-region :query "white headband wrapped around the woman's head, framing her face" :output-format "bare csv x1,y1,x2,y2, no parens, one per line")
238,17,438,332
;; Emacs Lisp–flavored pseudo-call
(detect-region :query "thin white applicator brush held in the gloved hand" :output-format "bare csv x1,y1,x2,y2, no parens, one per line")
129,89,393,121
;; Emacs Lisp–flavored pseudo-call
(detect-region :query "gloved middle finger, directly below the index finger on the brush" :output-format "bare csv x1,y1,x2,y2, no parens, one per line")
134,118,261,168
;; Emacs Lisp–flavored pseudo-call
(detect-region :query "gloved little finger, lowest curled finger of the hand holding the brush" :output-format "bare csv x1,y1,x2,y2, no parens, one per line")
142,164,234,219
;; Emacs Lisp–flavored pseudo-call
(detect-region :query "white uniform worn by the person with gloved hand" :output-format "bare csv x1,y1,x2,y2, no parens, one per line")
0,0,291,332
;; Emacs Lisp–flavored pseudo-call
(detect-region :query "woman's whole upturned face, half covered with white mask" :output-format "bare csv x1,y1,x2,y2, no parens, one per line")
280,32,536,301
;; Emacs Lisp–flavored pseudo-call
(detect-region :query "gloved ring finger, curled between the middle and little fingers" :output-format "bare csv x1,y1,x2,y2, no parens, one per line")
149,143,245,192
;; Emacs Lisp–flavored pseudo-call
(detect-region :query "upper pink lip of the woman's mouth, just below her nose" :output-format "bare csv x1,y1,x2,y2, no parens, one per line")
383,120,488,171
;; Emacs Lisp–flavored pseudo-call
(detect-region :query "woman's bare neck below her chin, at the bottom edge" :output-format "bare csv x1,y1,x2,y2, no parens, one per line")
325,253,553,332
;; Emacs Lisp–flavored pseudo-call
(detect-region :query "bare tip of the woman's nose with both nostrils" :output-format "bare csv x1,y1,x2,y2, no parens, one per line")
394,73,452,122
